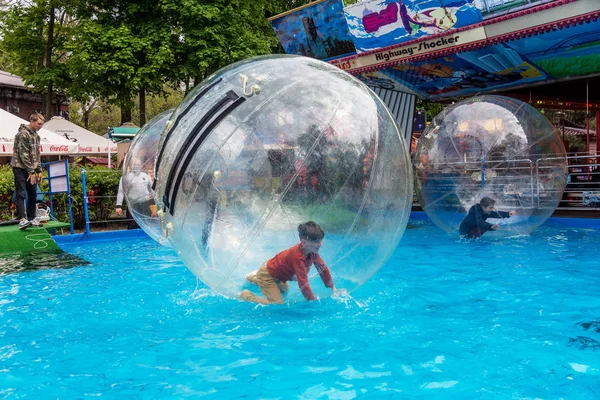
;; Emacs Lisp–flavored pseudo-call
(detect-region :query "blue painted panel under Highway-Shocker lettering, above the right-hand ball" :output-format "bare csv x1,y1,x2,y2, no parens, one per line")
381,45,547,100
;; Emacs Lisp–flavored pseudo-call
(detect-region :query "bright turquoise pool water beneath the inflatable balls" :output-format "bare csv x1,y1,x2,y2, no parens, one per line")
0,220,600,399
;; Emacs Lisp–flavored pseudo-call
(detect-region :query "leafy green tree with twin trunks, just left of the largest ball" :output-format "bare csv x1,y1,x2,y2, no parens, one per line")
69,0,174,125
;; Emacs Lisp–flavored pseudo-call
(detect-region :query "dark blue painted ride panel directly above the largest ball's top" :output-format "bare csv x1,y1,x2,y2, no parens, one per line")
269,0,355,60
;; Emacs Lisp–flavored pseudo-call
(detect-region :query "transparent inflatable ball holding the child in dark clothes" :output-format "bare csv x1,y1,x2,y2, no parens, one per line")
413,96,567,237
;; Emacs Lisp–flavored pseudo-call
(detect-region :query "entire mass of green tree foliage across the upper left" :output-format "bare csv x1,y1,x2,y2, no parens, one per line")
0,0,351,122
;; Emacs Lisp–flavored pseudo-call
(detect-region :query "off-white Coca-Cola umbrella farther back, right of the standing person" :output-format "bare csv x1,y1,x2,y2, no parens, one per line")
44,117,117,156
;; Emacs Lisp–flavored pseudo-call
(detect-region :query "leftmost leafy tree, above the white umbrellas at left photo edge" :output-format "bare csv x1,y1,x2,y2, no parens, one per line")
0,0,73,118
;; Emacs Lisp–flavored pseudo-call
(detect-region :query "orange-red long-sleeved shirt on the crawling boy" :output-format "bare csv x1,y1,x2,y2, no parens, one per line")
267,243,333,300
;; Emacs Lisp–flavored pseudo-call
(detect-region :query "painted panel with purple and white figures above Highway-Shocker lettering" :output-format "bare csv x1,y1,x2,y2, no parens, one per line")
344,0,482,52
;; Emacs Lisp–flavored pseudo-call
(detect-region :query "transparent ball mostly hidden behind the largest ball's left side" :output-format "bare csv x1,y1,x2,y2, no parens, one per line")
121,109,173,246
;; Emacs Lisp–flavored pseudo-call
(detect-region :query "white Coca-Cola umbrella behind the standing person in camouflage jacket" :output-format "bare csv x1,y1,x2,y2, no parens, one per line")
0,109,79,156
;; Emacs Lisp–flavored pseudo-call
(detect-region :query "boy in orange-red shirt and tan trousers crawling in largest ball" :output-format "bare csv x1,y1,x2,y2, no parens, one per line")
240,221,335,304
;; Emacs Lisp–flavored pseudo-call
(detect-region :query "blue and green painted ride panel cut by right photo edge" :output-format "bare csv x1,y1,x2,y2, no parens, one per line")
507,21,600,78
